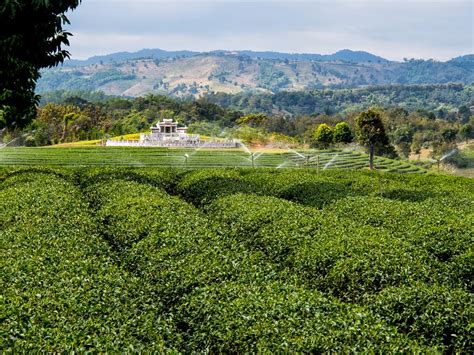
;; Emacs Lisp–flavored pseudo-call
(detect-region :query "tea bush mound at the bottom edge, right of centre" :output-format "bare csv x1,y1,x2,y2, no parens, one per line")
176,282,428,353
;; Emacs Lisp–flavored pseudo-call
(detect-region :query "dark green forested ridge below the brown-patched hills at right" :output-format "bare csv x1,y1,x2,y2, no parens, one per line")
206,84,474,119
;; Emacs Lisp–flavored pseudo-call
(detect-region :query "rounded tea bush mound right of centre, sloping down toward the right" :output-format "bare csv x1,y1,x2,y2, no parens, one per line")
207,194,436,301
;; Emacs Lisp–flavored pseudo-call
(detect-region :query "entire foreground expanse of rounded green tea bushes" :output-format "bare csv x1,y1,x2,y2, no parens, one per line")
0,166,474,353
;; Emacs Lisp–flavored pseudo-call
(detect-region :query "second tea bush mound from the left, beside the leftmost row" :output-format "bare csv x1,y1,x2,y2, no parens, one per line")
86,180,282,307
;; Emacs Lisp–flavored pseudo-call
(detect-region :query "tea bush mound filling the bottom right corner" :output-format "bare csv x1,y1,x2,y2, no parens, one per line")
367,284,474,353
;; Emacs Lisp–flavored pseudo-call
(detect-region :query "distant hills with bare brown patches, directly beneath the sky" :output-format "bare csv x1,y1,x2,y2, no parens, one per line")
37,50,474,97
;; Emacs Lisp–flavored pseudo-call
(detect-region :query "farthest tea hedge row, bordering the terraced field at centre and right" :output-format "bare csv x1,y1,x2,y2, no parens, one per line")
176,169,474,211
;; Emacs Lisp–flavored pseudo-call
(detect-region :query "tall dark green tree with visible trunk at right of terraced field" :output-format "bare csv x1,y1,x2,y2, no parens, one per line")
356,109,388,170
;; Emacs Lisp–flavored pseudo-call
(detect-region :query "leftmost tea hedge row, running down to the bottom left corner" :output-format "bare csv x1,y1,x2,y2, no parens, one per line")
0,172,170,352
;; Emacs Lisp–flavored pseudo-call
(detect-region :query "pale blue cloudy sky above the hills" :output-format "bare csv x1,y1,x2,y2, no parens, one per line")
68,0,474,60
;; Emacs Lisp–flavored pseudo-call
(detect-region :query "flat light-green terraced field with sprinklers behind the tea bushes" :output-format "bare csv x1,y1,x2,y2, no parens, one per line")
0,147,426,173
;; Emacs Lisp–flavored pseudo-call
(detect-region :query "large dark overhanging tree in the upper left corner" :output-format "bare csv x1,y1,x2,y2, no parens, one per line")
0,0,81,129
